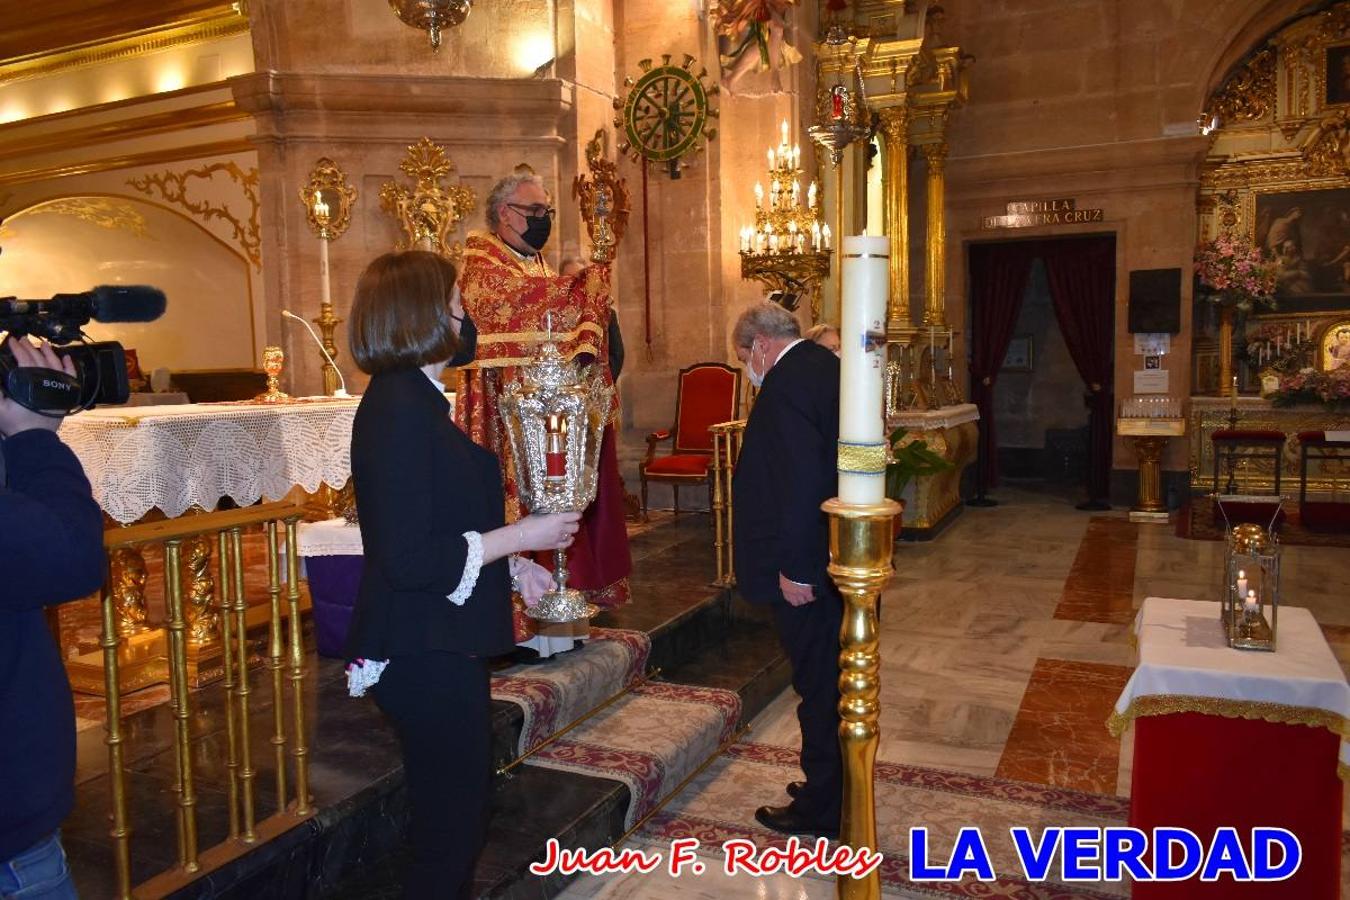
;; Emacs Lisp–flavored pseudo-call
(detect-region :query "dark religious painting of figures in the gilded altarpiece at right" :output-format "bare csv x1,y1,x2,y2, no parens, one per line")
1256,188,1350,312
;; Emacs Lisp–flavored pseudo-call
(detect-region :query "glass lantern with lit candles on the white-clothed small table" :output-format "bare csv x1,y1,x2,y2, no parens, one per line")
1220,522,1280,650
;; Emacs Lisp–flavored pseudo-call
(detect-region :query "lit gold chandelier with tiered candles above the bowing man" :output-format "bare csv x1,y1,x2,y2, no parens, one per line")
740,121,833,318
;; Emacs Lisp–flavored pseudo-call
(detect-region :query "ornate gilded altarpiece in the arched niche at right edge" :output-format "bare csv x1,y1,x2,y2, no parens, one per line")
1188,1,1350,497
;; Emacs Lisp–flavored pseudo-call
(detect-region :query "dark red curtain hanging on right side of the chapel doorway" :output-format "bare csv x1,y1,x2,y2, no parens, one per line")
1038,237,1115,503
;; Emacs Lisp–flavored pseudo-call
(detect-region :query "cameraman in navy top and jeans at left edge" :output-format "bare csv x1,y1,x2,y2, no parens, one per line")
0,337,105,900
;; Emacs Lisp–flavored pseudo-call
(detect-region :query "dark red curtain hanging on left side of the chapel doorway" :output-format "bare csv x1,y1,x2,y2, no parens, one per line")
969,240,1040,487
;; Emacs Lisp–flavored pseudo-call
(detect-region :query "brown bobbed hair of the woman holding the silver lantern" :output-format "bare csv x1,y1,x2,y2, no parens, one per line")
348,250,459,375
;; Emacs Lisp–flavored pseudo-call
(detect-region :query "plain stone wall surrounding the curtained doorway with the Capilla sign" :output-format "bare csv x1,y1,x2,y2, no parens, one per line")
946,0,1301,470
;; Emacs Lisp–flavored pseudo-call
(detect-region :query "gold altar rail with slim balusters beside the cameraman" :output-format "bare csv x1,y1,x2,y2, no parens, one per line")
100,502,313,899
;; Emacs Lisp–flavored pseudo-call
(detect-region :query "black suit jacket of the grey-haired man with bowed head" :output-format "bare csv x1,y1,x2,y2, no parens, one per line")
732,340,840,603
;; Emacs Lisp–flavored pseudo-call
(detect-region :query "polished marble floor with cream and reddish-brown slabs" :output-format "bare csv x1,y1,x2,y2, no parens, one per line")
563,488,1350,900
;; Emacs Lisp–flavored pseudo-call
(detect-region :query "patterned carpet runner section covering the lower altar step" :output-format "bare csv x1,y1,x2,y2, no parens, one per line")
528,681,741,828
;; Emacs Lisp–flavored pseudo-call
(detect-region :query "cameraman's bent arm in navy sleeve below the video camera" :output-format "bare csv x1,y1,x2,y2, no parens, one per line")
0,429,104,610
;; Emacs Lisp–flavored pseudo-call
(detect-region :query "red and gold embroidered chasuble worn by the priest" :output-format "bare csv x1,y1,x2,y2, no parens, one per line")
455,232,633,642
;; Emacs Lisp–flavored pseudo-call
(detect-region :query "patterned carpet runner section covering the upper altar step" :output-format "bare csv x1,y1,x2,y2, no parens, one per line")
491,627,652,756
